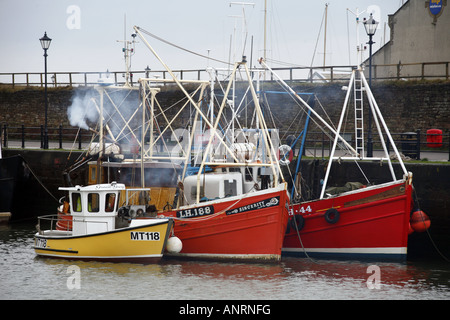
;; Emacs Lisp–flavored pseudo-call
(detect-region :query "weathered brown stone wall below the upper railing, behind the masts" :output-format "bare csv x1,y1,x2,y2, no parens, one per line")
0,82,450,133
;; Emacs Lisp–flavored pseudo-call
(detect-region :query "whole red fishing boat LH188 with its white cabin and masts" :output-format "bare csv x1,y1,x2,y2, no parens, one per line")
135,27,289,260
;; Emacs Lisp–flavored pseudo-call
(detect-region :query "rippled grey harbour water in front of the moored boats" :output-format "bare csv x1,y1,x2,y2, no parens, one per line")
0,223,450,301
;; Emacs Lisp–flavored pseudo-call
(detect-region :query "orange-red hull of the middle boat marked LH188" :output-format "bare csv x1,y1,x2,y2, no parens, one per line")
160,184,289,260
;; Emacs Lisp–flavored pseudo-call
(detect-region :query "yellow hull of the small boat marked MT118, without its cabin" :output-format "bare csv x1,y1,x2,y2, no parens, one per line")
34,220,173,262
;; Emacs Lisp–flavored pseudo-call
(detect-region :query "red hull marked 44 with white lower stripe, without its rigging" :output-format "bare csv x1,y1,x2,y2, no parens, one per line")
283,181,412,259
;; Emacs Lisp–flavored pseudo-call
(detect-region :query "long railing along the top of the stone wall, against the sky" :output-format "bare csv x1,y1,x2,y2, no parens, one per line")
0,61,450,87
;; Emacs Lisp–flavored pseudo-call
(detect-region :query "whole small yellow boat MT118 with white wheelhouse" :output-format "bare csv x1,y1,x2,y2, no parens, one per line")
34,182,180,262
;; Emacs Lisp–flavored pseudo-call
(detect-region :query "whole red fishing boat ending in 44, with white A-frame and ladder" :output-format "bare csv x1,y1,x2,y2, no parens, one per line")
261,61,430,260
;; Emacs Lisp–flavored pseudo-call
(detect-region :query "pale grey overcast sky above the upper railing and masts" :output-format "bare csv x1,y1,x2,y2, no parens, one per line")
0,0,402,72
